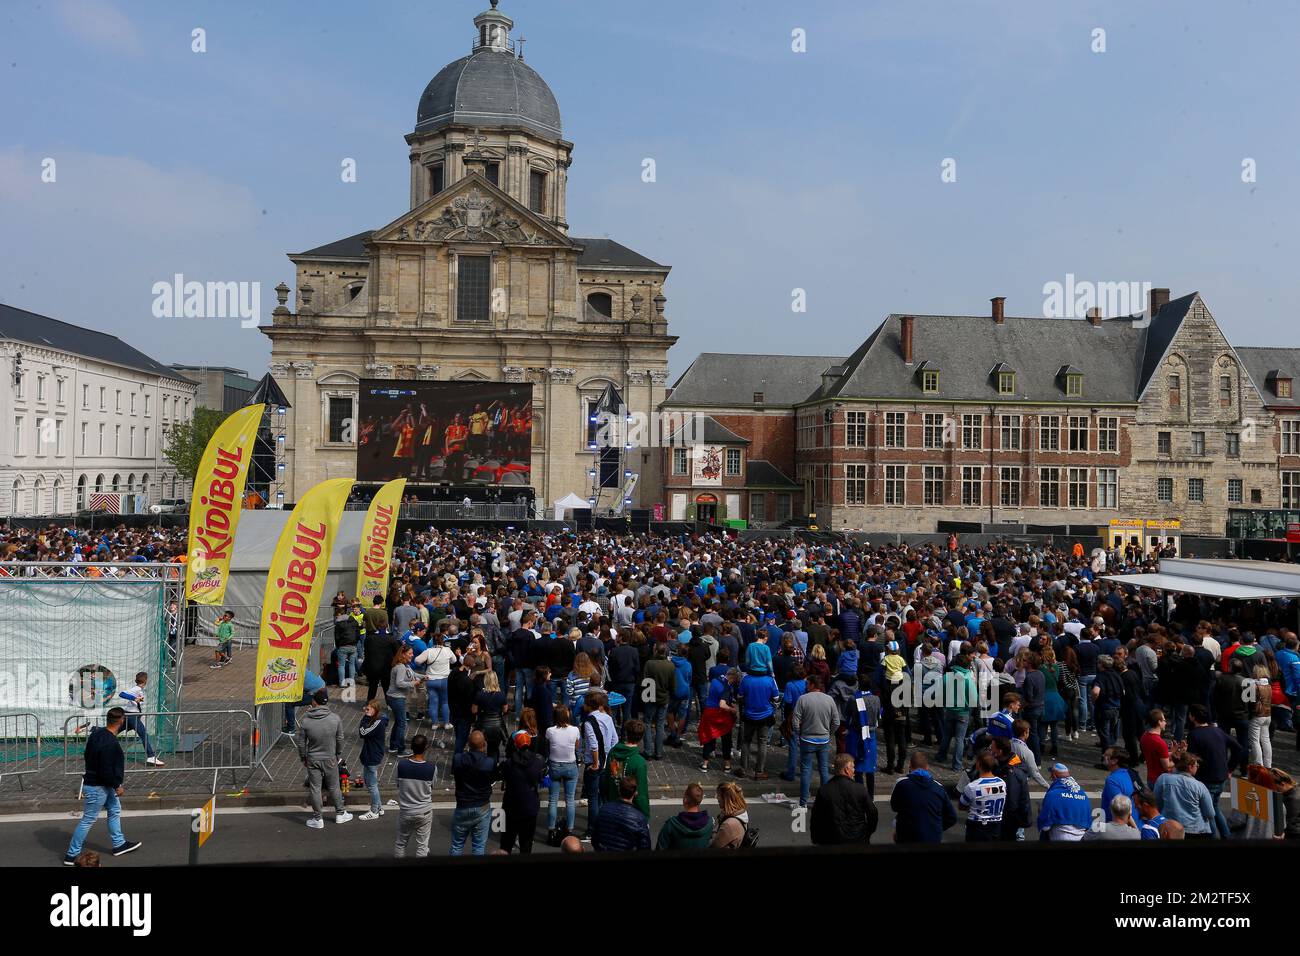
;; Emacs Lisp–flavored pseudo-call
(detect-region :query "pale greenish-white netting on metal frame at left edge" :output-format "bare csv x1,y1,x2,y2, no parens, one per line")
0,578,176,754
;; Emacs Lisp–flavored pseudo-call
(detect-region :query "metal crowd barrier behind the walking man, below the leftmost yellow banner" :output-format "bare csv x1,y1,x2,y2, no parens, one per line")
64,710,257,793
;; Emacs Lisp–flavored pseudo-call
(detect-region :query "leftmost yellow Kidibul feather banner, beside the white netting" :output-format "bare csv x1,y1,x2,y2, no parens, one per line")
185,405,267,605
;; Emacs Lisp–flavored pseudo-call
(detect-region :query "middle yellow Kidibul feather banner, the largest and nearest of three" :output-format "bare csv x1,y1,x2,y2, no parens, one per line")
254,479,352,704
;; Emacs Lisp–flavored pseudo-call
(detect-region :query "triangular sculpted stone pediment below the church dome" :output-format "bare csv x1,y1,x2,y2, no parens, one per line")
372,174,573,246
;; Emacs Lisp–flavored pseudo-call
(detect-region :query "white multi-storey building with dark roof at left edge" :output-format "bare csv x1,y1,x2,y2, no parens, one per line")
0,304,198,516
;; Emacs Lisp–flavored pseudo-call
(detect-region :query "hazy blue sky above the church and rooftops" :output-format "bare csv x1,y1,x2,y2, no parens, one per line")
0,0,1300,375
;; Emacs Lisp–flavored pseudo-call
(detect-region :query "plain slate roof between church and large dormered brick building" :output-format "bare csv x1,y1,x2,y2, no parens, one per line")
664,352,844,408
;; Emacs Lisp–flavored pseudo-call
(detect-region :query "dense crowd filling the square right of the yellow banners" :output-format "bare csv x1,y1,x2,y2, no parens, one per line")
48,528,1300,853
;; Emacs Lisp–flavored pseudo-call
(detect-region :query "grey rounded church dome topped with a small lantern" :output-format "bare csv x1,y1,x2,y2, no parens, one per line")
415,0,560,138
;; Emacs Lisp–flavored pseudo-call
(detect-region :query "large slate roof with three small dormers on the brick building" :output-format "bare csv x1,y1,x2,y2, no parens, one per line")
813,314,1154,403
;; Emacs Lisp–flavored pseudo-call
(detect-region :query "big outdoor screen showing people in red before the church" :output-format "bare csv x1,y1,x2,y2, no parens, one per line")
356,378,533,485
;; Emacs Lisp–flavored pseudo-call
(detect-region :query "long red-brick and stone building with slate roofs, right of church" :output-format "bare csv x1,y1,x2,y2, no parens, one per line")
666,289,1300,545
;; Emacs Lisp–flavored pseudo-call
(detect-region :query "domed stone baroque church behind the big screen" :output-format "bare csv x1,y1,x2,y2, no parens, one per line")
263,0,676,510
